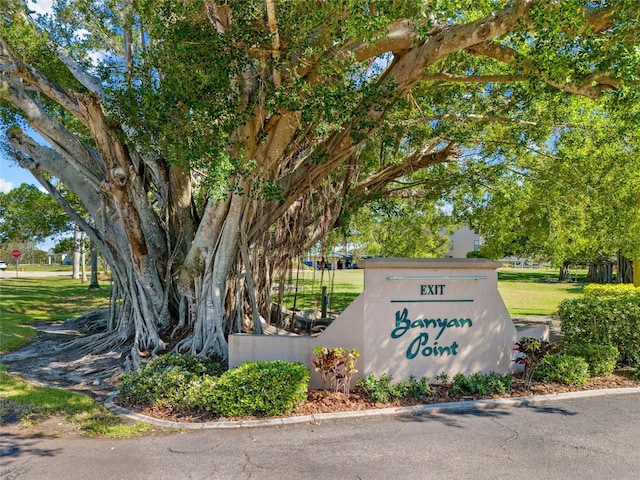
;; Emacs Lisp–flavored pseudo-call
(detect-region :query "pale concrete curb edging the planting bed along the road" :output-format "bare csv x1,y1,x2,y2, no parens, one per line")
105,388,640,430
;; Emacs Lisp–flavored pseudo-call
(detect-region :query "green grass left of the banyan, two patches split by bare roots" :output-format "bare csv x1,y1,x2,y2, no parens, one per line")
0,277,151,438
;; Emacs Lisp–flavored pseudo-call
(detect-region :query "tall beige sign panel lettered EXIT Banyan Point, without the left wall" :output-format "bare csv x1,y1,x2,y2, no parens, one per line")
364,259,516,380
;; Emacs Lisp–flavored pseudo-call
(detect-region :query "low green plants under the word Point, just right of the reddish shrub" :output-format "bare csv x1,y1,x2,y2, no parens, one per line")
355,373,435,403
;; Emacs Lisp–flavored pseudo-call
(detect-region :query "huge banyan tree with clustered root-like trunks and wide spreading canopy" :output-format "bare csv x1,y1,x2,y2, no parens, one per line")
0,0,640,361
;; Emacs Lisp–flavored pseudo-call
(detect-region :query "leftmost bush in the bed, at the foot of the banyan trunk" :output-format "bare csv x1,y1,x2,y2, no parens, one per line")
120,353,222,409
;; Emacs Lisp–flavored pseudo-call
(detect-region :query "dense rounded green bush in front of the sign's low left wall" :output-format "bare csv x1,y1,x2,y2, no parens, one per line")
211,360,310,417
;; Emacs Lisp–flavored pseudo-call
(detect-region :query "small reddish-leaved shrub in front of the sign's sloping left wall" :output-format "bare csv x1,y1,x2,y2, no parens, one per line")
312,346,360,394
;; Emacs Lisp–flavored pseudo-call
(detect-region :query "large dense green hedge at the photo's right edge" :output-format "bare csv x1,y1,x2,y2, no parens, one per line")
558,288,640,366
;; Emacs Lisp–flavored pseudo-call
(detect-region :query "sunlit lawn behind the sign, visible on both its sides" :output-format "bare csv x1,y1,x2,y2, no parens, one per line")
274,268,586,316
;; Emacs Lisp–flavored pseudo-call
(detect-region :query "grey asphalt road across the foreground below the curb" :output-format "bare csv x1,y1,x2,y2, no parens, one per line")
0,394,640,480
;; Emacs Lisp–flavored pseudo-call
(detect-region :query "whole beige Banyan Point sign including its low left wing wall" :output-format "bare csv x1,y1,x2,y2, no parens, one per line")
229,258,517,388
